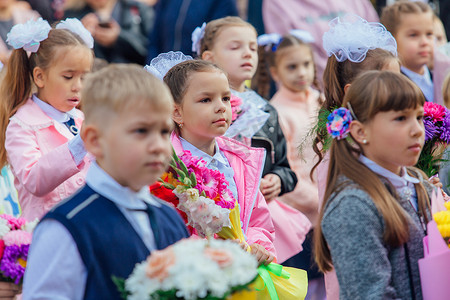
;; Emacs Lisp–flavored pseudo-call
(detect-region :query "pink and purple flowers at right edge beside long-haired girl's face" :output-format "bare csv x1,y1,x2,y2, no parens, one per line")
416,102,450,177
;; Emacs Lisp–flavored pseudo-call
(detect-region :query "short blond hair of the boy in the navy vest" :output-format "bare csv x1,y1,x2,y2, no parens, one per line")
81,64,173,124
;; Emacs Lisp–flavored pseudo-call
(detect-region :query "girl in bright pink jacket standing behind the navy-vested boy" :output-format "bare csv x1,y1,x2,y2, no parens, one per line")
164,60,275,263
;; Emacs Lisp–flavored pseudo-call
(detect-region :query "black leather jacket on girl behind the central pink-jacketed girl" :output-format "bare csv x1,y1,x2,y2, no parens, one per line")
244,91,297,196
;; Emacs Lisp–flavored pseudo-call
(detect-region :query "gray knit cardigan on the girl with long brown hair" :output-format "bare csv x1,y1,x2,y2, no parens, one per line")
321,172,434,300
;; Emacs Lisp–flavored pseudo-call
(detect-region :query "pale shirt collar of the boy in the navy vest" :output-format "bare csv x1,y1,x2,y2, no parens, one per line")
86,162,161,210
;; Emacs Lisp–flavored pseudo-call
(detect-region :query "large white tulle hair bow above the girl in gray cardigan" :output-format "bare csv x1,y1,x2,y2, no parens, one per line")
322,14,397,63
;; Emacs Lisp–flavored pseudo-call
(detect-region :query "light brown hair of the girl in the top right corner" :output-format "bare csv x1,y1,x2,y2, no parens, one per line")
380,0,433,36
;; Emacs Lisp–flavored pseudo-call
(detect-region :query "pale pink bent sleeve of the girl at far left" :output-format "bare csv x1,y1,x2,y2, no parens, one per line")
5,120,84,197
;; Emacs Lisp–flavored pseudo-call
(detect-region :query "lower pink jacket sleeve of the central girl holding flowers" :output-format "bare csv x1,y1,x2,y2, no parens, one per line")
246,190,276,257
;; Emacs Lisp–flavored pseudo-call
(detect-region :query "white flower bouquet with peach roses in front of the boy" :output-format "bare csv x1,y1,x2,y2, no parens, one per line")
115,239,258,300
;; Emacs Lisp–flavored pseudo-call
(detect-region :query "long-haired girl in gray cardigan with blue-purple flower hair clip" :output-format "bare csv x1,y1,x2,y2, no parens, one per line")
315,71,435,299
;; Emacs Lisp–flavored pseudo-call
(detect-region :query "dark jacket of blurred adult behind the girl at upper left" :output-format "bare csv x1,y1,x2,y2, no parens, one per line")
65,0,154,65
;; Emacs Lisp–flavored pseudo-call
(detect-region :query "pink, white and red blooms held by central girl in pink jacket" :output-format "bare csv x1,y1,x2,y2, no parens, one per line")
150,151,236,238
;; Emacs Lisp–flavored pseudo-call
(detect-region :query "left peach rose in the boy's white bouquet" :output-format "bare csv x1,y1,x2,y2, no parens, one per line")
146,247,175,282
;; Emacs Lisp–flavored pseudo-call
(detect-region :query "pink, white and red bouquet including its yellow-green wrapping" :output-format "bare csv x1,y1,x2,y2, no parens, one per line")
149,151,307,299
